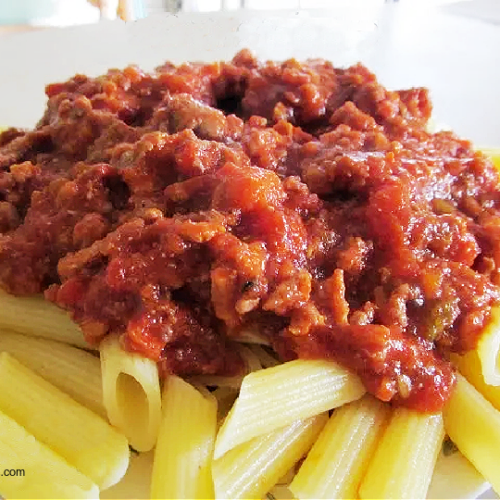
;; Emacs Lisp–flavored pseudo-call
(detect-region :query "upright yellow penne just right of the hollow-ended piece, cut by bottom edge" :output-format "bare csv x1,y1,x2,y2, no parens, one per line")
151,375,217,499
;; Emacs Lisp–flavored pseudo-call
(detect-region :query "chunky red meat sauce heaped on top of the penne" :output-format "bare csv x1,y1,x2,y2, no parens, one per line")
0,51,500,411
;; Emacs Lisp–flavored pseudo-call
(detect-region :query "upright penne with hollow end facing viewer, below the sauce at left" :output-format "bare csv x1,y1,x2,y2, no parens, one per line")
100,335,161,451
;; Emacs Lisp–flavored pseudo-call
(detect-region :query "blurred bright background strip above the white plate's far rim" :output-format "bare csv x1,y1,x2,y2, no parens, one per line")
0,0,494,28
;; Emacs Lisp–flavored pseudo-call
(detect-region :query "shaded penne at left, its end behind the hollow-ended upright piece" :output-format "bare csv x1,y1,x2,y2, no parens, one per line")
0,331,107,418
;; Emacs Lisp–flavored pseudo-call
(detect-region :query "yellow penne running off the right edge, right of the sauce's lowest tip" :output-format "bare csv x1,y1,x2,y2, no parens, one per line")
443,375,500,493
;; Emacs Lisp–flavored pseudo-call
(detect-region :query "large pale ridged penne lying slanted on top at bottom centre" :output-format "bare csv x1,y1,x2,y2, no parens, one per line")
214,360,365,459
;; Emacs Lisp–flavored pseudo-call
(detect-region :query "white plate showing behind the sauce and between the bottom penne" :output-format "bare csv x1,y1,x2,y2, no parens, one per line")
0,0,500,498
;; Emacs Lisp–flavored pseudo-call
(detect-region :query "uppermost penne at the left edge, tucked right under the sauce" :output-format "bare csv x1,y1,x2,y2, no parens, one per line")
0,290,89,349
